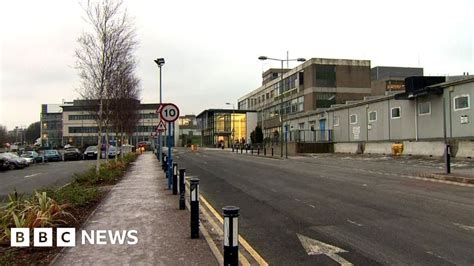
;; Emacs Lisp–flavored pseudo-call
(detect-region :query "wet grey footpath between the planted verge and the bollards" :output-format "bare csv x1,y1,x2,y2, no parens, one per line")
52,152,218,265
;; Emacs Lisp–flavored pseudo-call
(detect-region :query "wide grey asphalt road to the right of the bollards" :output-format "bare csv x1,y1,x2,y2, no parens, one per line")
176,150,474,265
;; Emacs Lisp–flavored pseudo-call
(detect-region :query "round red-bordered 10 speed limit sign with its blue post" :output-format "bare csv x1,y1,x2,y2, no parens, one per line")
160,103,179,189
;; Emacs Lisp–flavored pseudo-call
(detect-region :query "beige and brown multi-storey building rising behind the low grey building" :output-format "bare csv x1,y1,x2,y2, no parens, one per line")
238,58,371,138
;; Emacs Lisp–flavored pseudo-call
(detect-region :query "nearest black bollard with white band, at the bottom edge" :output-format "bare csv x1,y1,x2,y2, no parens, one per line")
222,206,240,266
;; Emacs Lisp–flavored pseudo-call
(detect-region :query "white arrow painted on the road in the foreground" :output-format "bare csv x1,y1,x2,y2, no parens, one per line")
296,234,353,265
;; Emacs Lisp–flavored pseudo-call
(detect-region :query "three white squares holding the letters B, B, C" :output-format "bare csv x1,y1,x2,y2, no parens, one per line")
10,227,76,247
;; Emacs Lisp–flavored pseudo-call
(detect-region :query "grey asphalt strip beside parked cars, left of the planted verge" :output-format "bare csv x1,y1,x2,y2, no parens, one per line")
0,160,95,200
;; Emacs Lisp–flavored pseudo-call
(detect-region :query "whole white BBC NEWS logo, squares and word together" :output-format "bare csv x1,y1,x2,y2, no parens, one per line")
10,228,138,247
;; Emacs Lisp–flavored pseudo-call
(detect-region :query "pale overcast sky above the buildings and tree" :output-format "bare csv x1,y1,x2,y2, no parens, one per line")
0,0,474,129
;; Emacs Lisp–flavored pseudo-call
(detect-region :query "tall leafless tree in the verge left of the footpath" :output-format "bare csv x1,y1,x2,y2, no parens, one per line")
76,0,137,171
